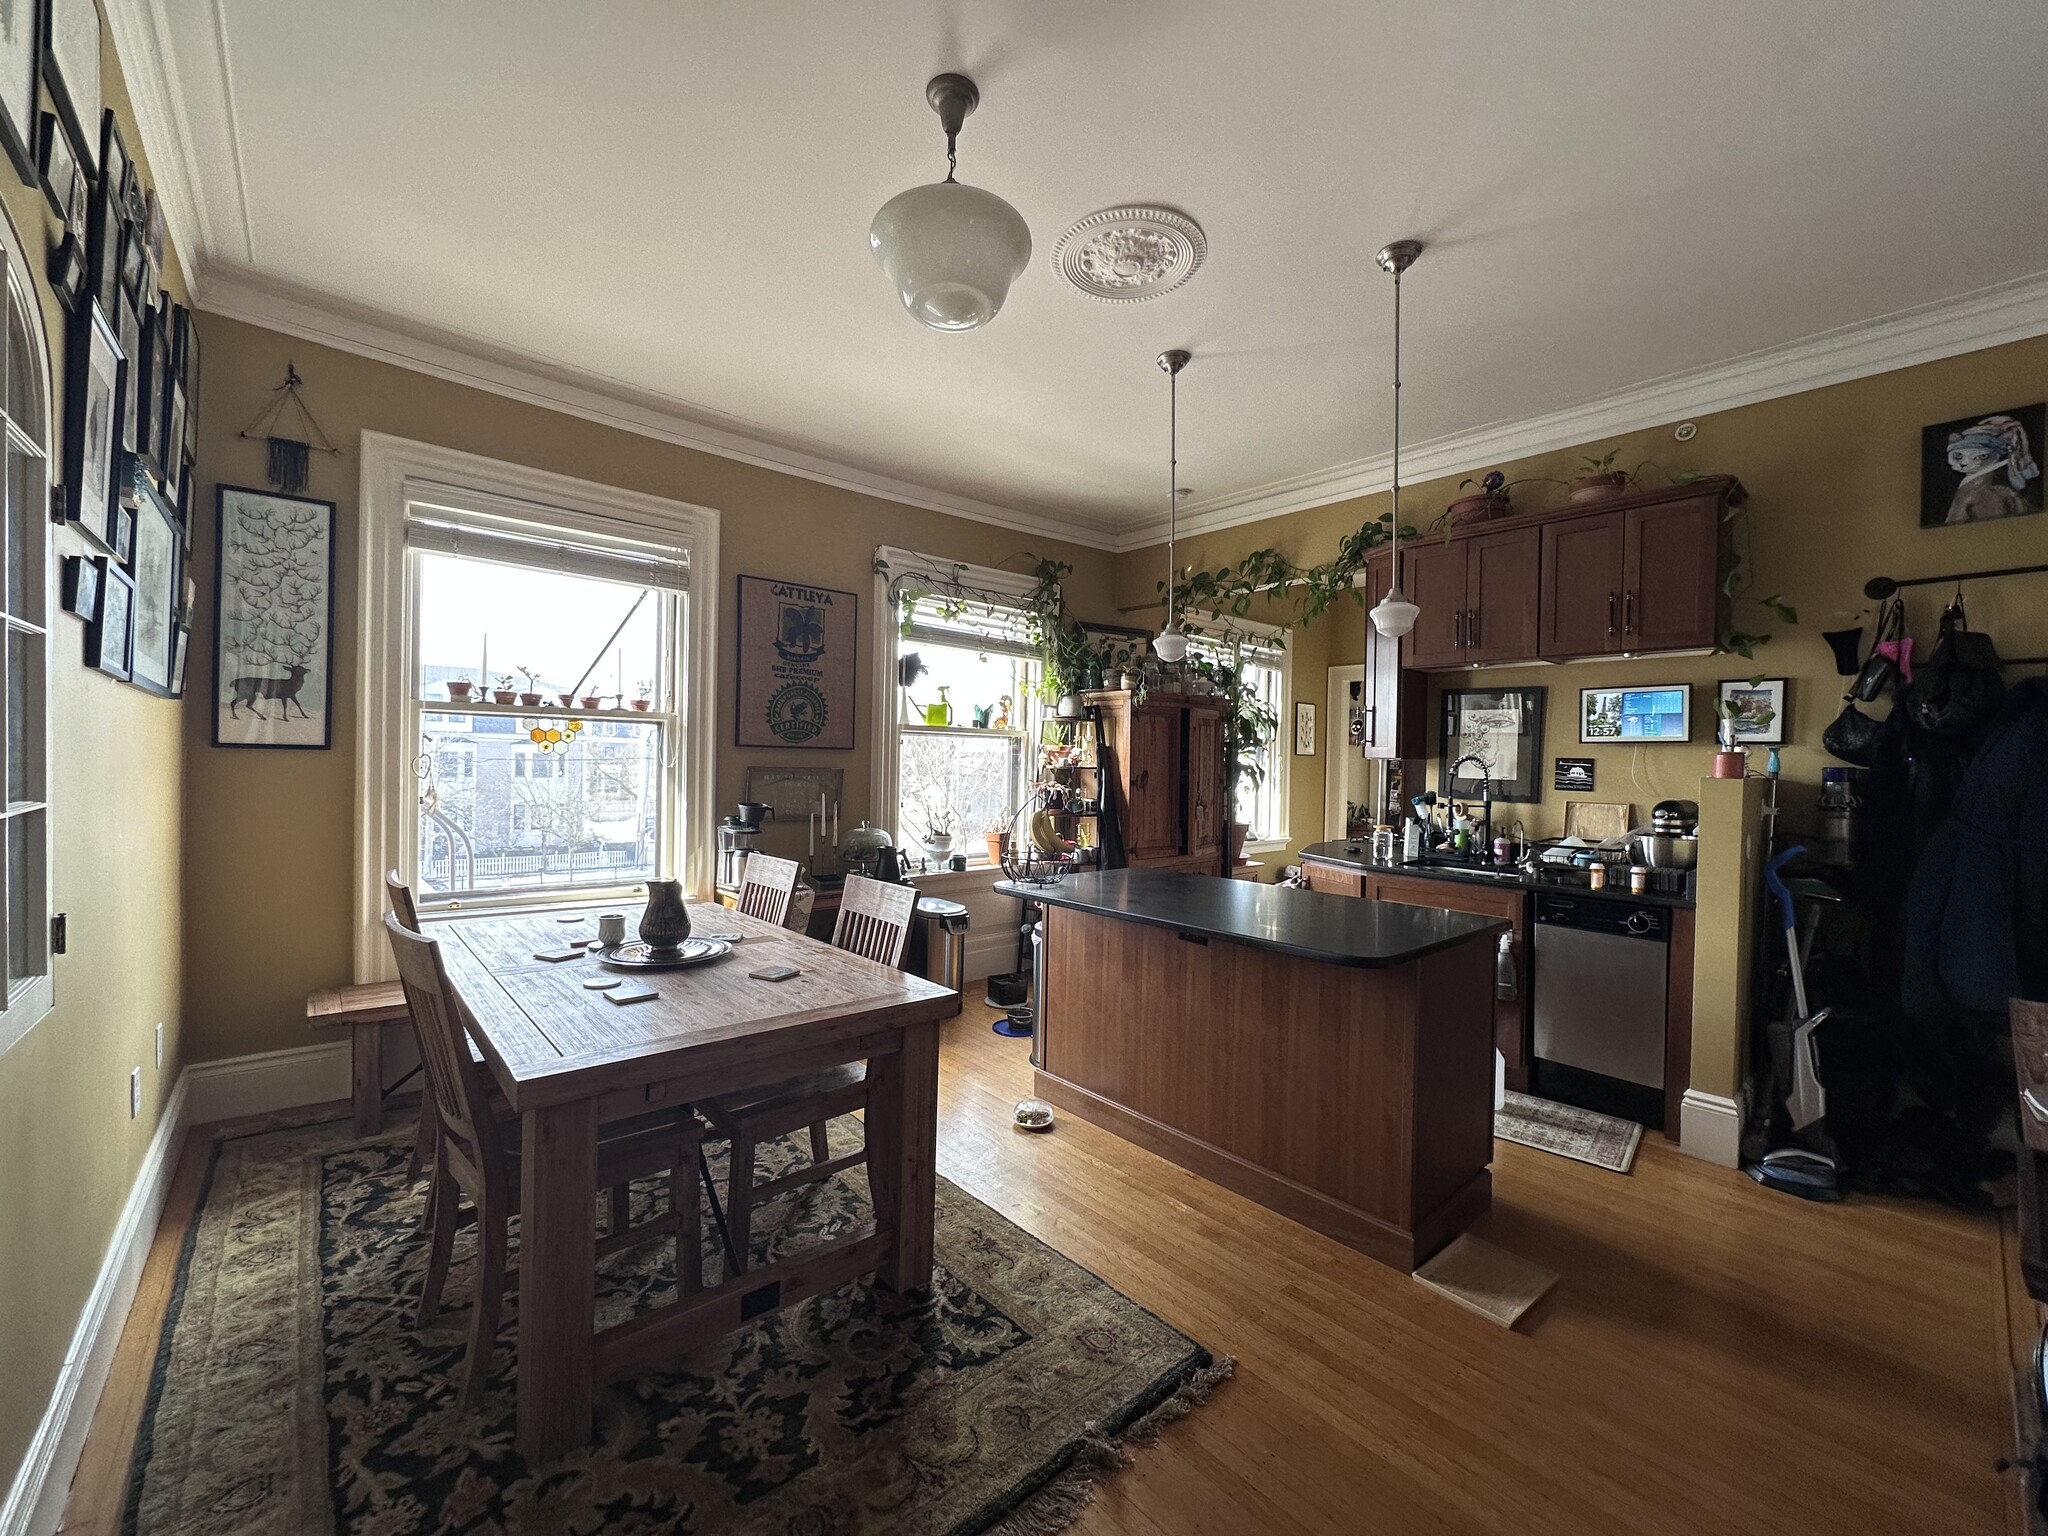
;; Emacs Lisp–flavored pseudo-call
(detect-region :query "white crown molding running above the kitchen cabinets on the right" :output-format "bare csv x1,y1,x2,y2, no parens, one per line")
1116,272,2048,551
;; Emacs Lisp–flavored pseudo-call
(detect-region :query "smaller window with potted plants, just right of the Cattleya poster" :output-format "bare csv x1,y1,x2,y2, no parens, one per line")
877,551,1040,864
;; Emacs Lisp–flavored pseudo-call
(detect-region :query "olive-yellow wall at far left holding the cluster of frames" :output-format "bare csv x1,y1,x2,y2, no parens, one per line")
0,18,184,1497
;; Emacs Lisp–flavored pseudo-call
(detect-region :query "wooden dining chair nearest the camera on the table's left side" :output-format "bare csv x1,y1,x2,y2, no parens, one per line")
385,913,705,1407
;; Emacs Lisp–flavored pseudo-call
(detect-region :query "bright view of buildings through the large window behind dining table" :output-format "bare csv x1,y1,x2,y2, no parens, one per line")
416,553,682,899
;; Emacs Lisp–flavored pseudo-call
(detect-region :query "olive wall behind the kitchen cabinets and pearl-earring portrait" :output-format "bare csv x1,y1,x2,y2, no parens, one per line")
1116,338,2048,864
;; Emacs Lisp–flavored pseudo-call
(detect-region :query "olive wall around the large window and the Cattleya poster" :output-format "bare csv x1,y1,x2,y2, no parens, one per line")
184,313,1110,1061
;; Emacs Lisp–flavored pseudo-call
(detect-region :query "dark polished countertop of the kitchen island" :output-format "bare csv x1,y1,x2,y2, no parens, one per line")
995,868,1509,969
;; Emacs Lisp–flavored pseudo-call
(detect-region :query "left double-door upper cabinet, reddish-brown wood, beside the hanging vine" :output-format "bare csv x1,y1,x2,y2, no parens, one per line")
1403,524,1542,672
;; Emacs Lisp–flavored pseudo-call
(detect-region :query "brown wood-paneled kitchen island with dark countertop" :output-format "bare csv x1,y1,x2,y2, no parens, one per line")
995,868,1507,1270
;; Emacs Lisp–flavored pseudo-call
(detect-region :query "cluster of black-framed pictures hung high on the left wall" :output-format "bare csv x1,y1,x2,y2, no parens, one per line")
0,0,199,698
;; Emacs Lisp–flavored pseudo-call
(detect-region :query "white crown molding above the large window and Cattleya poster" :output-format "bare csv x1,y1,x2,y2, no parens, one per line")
205,264,1116,551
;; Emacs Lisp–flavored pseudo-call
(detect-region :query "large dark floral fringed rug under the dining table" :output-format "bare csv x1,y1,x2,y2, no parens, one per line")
125,1124,1231,1536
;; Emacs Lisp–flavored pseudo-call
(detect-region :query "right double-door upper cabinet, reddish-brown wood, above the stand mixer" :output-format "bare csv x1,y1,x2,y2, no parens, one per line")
1536,477,1743,659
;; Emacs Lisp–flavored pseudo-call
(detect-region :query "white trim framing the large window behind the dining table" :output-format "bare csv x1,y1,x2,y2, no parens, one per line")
354,432,719,981
